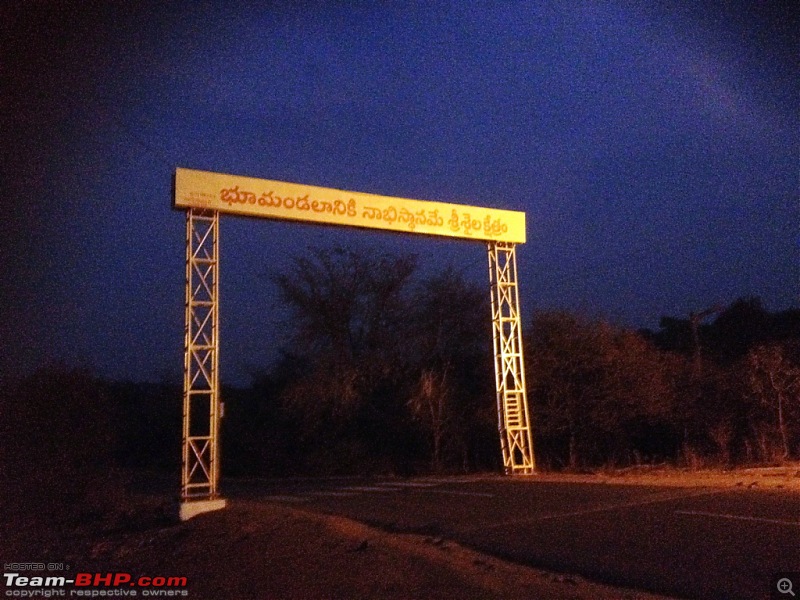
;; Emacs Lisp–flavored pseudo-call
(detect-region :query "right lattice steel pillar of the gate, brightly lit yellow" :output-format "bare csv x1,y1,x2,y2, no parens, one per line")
488,242,536,474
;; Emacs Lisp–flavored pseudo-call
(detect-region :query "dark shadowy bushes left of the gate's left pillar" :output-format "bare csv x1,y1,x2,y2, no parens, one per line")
0,366,182,526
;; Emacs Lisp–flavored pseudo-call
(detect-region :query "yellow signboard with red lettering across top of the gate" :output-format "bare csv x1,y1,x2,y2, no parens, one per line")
175,168,525,244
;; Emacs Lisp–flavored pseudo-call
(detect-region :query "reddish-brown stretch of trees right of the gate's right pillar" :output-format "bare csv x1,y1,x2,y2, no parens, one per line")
526,298,800,469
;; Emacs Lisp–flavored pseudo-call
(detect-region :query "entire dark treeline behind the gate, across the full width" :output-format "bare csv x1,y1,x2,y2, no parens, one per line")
0,248,800,497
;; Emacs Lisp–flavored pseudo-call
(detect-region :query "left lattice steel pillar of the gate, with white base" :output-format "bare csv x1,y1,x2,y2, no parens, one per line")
181,209,225,519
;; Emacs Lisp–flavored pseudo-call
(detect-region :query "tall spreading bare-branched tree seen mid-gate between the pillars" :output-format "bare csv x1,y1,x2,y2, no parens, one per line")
273,247,416,469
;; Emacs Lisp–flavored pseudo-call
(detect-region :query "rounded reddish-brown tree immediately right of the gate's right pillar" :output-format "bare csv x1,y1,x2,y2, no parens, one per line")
526,313,675,469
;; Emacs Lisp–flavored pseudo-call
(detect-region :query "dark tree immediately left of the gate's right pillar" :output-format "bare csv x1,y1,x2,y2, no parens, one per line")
406,267,497,470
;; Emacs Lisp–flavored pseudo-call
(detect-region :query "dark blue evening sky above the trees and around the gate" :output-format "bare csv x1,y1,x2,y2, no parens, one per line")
0,1,800,382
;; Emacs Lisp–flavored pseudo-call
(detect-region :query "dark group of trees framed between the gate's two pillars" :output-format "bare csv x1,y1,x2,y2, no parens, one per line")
224,248,499,474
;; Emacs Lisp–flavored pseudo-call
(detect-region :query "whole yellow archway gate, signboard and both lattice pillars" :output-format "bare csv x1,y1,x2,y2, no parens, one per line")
175,168,535,519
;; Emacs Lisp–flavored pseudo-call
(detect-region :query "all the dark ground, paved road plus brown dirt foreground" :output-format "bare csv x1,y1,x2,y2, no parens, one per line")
0,469,800,599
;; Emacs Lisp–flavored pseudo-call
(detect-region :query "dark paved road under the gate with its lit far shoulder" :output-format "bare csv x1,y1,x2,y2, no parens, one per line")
225,468,800,599
